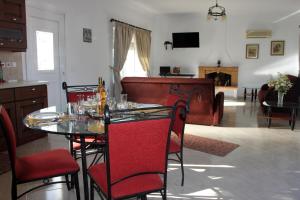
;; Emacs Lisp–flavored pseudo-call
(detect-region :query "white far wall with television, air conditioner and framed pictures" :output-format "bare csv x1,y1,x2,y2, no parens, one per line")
152,13,300,94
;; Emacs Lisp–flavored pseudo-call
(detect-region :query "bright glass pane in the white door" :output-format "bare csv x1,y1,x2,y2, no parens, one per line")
36,31,54,71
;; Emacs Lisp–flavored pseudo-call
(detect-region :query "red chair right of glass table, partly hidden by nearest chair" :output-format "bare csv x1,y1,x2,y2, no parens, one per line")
169,100,187,186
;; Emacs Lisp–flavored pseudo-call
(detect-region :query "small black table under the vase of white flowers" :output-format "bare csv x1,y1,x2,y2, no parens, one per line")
263,101,300,130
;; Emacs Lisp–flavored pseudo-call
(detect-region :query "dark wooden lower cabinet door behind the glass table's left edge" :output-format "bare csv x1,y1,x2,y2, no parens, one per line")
16,98,47,145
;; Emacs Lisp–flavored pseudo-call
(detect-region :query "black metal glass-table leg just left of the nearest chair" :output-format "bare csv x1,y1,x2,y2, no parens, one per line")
80,136,89,200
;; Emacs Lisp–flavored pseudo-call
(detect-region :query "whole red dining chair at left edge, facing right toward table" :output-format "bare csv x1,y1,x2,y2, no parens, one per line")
0,105,80,200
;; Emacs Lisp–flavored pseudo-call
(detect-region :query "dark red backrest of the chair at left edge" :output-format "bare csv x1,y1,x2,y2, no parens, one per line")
0,105,17,169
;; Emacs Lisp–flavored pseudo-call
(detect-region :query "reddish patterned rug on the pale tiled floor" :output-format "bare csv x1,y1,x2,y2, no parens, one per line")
172,134,240,157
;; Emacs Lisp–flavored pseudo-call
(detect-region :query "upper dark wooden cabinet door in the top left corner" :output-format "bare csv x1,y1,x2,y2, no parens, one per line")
0,0,26,24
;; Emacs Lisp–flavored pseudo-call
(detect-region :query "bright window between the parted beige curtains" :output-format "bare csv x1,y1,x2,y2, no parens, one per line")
121,36,147,78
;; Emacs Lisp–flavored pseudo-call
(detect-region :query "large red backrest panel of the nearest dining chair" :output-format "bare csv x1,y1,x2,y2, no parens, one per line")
108,118,171,183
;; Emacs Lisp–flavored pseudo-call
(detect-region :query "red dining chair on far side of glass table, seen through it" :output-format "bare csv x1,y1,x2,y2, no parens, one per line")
62,82,105,164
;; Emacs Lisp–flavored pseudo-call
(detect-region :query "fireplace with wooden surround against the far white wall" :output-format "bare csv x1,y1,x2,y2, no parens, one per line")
199,66,238,87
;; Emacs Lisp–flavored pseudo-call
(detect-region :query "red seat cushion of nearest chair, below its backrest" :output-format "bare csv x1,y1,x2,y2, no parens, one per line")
88,163,163,199
